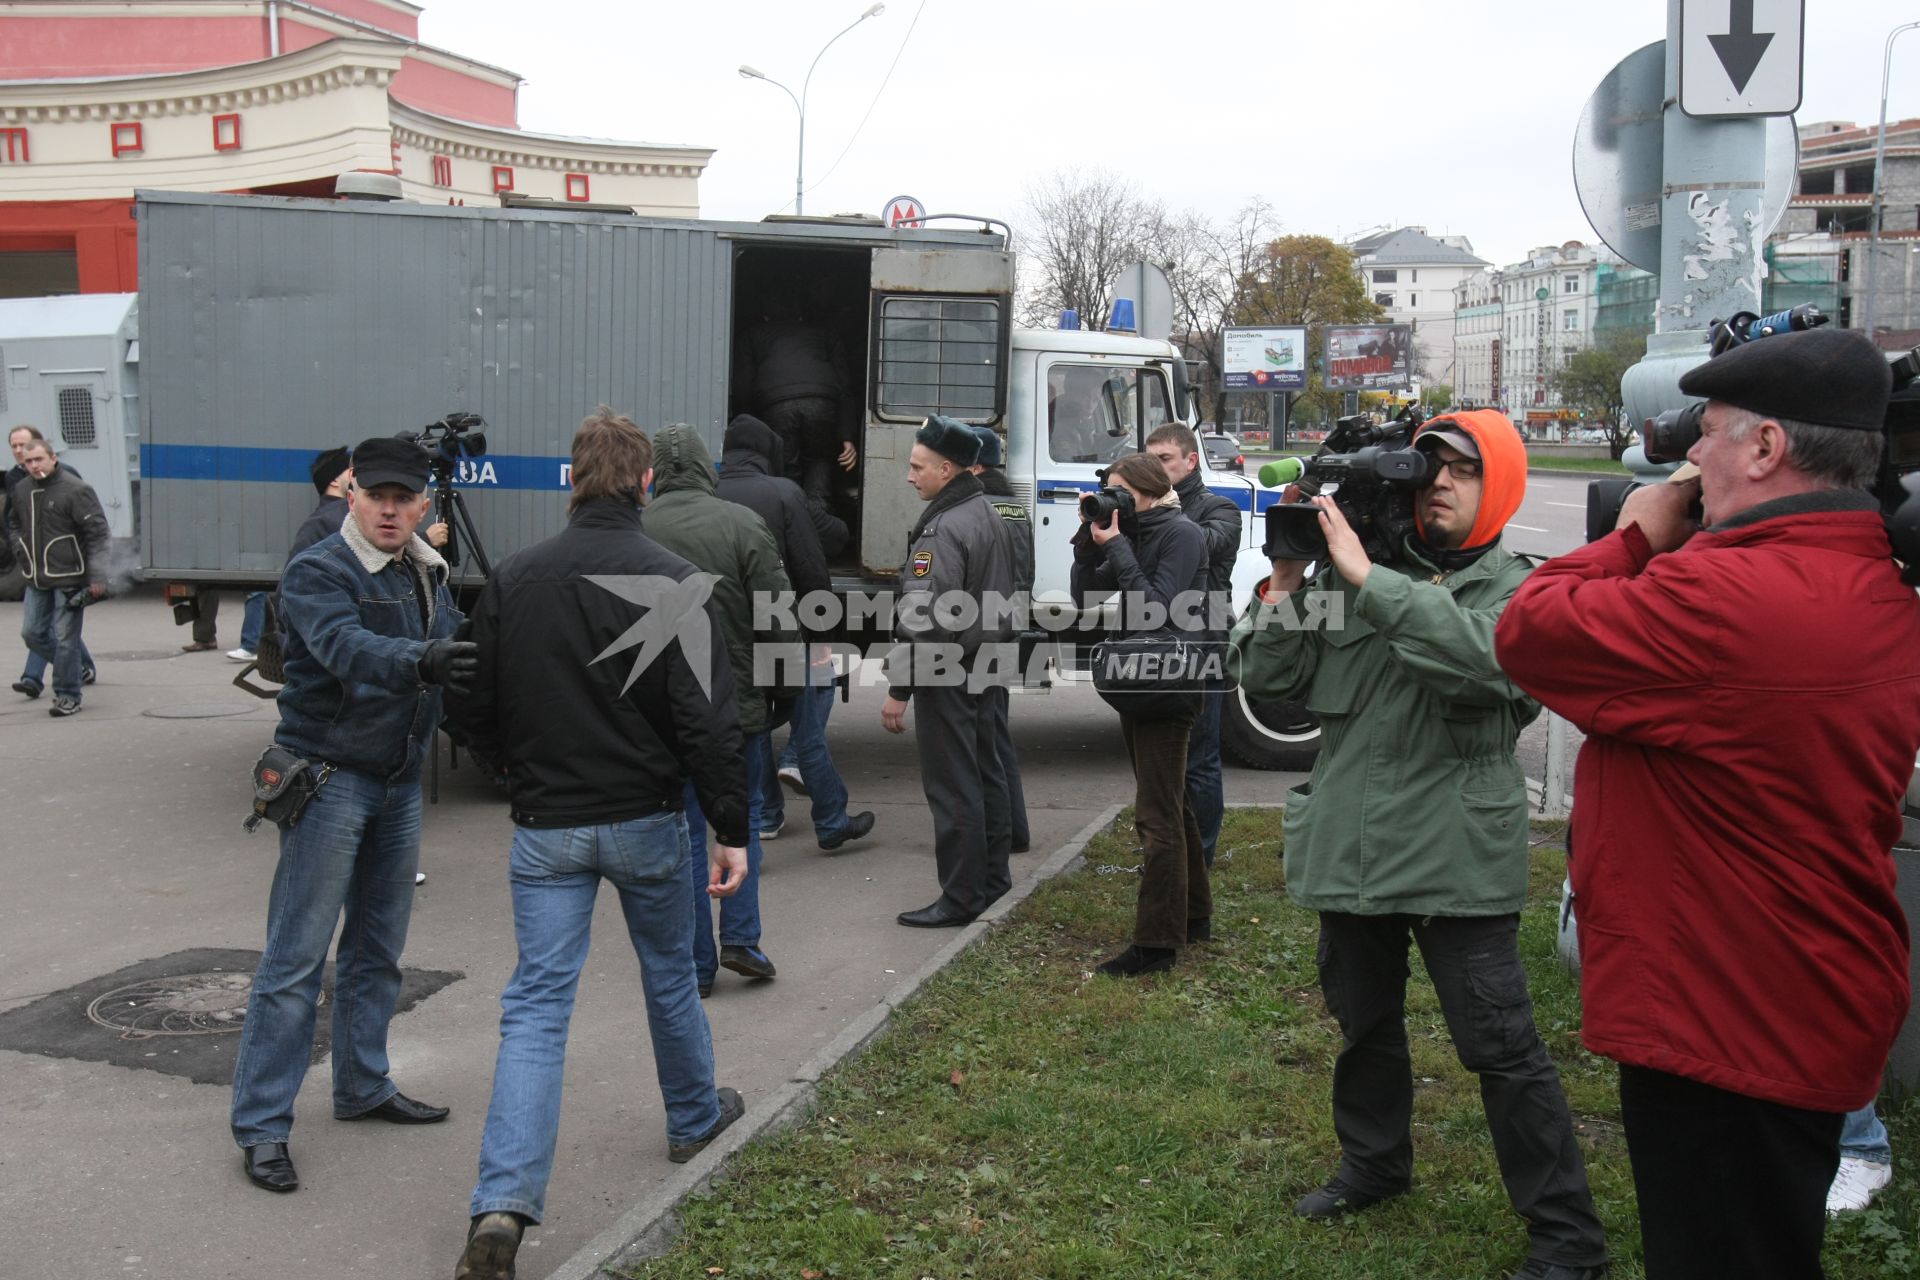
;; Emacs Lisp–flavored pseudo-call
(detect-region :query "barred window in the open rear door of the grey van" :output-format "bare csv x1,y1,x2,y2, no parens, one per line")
874,296,1006,422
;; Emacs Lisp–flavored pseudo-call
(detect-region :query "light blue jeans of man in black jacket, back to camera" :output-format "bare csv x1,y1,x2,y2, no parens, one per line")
470,812,720,1222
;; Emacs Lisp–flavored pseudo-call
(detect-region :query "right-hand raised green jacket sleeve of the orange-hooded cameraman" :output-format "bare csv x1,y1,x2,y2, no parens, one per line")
1354,564,1532,720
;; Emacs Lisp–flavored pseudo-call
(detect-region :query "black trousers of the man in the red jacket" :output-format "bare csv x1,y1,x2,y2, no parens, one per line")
1620,1067,1847,1280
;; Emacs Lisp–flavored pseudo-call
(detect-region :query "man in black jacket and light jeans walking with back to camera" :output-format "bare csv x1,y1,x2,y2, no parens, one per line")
451,407,747,1280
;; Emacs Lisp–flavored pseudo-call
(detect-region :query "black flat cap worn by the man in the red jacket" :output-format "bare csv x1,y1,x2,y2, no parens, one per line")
1680,328,1893,432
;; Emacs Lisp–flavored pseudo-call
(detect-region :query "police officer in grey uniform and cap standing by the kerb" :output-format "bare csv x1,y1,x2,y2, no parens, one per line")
879,415,1018,929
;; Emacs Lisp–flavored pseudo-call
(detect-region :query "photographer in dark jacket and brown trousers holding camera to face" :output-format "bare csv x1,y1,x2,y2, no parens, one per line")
1073,453,1213,977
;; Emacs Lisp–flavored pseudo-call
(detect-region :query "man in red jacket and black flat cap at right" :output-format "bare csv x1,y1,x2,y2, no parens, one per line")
1496,330,1920,1280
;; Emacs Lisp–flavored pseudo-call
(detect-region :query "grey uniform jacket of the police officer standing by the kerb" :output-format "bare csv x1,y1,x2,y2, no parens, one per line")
887,472,1018,700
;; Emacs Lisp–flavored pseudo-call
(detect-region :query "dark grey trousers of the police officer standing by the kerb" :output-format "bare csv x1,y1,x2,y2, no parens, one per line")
914,685,1014,915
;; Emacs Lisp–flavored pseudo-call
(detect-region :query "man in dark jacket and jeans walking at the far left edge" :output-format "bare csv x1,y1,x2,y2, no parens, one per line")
13,439,109,718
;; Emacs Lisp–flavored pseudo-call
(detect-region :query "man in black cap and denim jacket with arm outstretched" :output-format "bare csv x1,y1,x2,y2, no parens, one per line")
232,436,478,1192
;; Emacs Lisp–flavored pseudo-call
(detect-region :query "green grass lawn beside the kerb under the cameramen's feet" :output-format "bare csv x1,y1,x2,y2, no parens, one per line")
628,810,1920,1280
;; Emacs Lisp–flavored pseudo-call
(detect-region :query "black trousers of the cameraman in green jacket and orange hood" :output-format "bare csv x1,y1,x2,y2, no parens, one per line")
1317,912,1607,1267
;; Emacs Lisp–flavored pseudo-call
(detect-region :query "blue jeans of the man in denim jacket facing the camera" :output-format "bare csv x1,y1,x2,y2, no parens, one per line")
232,770,420,1148
